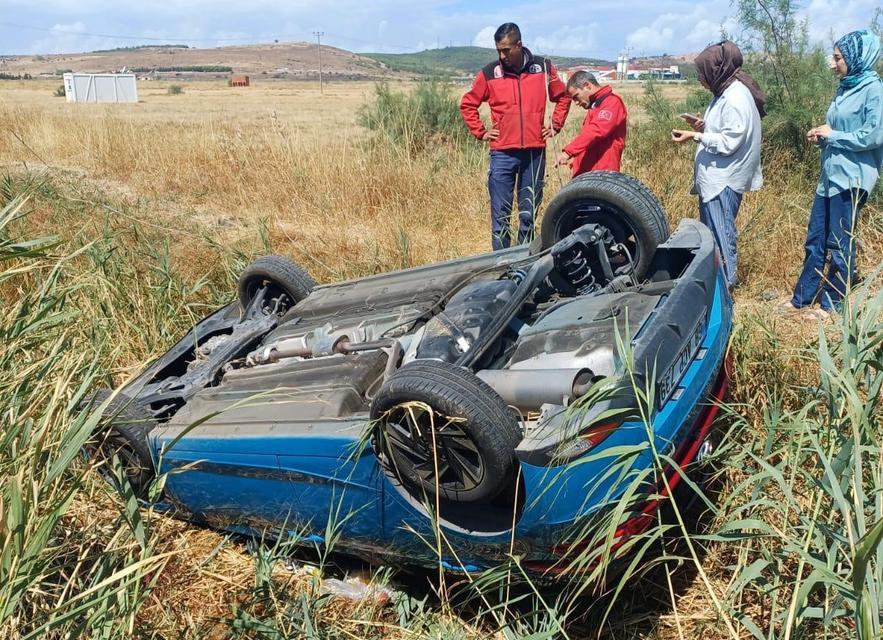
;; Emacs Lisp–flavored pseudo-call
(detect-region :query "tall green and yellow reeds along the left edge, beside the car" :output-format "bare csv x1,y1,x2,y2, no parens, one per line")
0,191,173,638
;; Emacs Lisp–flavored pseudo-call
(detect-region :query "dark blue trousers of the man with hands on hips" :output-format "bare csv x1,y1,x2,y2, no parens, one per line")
487,149,546,251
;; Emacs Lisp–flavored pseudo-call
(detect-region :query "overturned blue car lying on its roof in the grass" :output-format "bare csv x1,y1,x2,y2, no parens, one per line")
95,172,732,572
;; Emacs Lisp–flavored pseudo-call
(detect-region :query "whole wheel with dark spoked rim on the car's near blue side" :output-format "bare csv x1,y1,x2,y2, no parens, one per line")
371,360,522,503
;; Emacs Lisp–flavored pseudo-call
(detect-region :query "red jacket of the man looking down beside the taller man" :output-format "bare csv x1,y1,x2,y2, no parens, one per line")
563,85,628,177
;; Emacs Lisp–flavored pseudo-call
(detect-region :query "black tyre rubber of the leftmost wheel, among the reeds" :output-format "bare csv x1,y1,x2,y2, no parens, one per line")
82,389,156,498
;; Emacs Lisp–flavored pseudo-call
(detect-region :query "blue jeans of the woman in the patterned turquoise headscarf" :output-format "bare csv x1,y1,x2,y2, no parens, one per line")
791,189,868,311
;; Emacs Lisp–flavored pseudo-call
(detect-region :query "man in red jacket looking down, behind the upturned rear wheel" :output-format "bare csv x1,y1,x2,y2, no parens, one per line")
556,71,628,178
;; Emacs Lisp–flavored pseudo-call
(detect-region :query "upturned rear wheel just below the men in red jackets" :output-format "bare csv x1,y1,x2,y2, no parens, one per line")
535,171,669,279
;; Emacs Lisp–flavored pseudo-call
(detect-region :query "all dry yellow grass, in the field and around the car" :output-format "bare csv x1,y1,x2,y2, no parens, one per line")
0,76,883,639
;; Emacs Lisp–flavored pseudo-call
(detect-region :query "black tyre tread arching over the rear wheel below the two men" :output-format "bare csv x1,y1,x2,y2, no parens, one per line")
532,171,670,278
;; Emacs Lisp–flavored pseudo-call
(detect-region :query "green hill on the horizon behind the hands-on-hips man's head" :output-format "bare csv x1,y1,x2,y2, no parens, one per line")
361,47,612,76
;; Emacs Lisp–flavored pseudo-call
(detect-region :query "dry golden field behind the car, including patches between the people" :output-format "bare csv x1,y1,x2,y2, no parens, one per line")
0,81,883,370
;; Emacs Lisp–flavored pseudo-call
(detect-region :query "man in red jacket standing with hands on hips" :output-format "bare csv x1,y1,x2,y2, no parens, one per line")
460,22,570,250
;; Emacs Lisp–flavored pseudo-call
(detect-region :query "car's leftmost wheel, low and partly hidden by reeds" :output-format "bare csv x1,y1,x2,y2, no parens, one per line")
82,389,156,498
